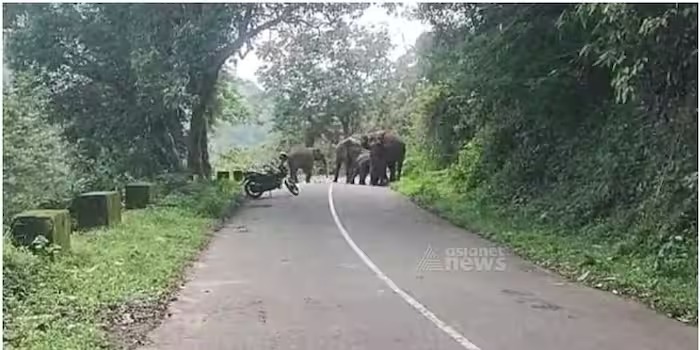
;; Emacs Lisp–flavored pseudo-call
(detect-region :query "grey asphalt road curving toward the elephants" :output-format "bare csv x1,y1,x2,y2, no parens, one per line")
143,183,698,350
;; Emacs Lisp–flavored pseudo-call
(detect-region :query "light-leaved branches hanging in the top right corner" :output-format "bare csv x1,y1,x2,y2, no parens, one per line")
561,4,698,106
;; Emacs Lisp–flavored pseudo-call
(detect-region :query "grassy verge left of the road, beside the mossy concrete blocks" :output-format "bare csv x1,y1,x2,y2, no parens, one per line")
3,179,240,349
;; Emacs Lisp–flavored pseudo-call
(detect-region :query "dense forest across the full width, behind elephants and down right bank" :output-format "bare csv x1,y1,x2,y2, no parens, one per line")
3,3,698,346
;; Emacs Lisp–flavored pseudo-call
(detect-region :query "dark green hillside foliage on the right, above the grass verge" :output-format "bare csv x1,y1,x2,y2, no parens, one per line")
408,4,697,243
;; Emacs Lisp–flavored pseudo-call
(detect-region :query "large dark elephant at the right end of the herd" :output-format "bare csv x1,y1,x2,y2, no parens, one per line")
361,131,406,185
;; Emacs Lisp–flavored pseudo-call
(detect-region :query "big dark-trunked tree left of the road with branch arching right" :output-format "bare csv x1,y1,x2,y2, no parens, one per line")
6,4,364,180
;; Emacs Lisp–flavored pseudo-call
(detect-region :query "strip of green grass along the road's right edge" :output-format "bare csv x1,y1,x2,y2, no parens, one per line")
392,172,698,325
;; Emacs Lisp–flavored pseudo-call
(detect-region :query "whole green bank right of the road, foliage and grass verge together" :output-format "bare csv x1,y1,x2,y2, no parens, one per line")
388,4,698,322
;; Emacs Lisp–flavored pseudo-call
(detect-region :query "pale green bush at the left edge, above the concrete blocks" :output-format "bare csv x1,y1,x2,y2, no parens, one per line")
3,73,80,221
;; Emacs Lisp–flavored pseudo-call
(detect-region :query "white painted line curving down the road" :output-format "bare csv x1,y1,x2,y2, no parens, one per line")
328,184,481,350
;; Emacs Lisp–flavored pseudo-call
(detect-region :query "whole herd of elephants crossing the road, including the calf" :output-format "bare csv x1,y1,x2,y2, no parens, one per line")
287,131,406,186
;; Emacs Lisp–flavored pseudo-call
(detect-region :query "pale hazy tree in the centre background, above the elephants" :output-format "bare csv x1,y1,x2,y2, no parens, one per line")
259,21,391,146
